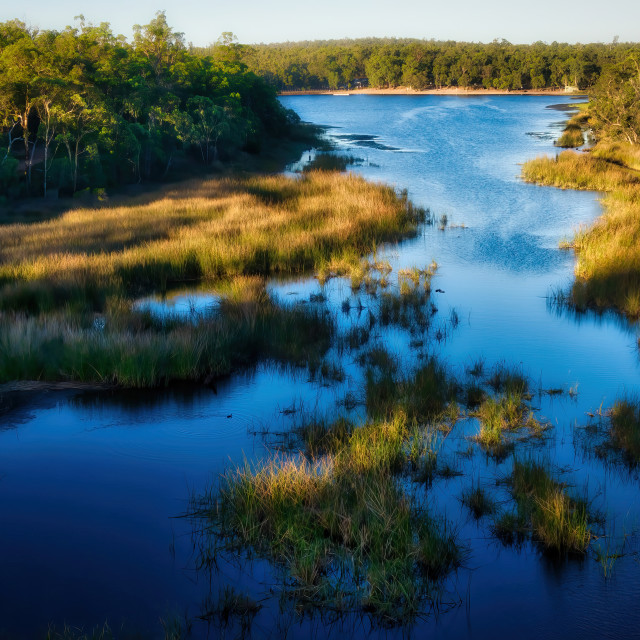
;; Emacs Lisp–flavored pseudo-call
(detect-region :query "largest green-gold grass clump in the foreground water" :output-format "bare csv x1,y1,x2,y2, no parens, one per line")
192,414,461,624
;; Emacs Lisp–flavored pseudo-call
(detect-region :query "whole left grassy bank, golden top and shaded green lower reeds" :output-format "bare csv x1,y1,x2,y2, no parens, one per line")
0,172,425,387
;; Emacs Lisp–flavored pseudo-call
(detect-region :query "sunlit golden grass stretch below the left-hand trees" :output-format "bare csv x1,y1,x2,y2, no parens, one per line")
0,172,420,310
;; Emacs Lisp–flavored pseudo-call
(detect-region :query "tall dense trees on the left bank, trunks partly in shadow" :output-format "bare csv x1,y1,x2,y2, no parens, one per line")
0,12,297,200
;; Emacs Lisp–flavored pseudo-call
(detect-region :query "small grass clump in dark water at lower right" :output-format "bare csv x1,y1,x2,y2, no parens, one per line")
502,460,592,554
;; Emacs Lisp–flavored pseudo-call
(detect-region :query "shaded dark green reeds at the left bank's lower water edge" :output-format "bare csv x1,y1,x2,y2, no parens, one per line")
0,279,334,387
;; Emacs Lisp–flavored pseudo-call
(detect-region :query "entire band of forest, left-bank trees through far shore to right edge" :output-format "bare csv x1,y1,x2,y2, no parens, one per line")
0,12,640,203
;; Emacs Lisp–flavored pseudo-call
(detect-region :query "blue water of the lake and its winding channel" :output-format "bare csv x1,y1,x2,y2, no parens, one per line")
0,96,640,639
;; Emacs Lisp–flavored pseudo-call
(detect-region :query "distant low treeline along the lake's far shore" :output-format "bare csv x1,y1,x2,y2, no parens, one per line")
195,34,640,91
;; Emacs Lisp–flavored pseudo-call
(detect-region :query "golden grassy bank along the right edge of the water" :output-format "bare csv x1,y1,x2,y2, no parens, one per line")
522,143,640,318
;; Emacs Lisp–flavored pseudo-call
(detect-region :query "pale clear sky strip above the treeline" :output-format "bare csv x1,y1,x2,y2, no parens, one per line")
0,0,640,45
